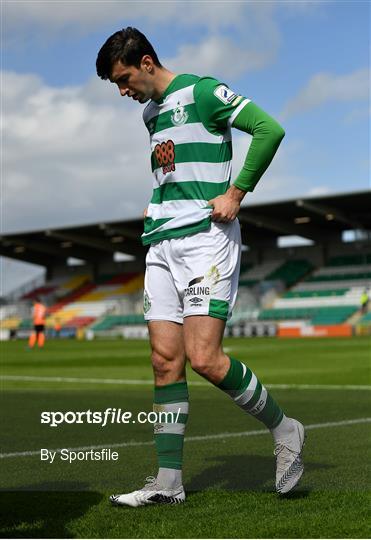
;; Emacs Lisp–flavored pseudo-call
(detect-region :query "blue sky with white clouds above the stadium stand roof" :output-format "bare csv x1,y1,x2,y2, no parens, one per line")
2,0,370,296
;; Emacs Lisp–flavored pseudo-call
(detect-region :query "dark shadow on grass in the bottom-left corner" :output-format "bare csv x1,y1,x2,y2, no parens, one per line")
0,482,103,538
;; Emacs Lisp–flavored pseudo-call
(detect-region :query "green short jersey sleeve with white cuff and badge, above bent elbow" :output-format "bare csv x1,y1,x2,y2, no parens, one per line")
194,77,250,134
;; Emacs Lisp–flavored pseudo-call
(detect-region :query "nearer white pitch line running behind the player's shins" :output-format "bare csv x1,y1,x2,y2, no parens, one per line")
0,418,371,459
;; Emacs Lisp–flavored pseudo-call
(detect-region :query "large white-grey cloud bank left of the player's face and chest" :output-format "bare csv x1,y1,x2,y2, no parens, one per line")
3,73,151,230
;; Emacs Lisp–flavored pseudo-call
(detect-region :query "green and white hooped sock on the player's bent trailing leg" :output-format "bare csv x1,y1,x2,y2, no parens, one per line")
217,358,284,430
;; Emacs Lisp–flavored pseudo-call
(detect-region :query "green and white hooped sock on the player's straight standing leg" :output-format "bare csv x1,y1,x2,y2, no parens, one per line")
153,381,189,489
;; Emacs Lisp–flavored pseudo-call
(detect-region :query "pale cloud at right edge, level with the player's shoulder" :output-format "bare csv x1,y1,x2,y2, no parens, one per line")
281,68,369,118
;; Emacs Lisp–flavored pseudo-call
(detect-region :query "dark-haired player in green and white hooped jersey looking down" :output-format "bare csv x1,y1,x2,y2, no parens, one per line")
96,27,304,506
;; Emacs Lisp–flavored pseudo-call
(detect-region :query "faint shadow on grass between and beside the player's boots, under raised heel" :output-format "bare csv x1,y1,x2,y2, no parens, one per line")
186,454,330,498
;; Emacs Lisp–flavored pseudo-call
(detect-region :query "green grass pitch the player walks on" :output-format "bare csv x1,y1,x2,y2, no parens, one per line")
0,338,371,538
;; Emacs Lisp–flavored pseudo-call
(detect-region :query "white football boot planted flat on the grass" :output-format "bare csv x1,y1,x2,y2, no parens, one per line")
110,476,185,507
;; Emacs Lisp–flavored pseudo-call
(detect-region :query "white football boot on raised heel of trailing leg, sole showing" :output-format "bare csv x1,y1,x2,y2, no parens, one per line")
274,418,305,494
